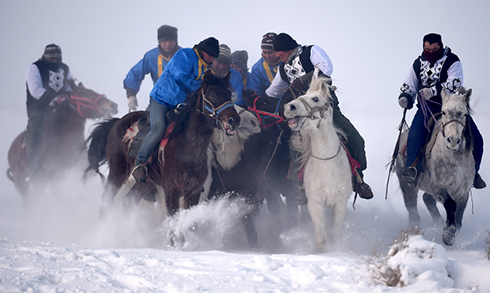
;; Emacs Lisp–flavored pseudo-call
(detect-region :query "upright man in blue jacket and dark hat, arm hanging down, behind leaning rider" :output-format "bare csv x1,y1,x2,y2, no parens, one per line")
123,25,181,111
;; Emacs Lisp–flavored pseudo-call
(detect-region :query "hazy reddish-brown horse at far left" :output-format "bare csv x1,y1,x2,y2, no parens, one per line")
7,83,117,200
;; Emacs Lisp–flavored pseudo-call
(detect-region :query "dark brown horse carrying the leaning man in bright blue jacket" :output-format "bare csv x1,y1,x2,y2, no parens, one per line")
102,72,240,220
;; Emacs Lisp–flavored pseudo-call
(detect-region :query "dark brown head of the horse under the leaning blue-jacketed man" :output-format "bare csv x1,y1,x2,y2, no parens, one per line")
196,71,240,135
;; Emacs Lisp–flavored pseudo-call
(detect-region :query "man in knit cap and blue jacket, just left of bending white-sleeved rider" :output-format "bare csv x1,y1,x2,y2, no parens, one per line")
247,33,282,96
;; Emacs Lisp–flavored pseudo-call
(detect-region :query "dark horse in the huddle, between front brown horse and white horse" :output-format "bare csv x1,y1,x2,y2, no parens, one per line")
210,87,299,247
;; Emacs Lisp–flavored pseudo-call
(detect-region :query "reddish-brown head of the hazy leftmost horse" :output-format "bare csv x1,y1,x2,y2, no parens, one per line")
70,83,117,119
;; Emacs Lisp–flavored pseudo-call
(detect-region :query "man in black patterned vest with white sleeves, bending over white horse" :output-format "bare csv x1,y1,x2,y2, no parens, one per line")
265,33,373,199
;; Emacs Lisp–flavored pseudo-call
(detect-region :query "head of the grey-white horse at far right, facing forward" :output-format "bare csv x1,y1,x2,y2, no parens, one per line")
439,87,472,151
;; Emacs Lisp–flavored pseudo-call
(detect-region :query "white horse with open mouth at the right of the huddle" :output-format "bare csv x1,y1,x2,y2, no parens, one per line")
284,77,353,252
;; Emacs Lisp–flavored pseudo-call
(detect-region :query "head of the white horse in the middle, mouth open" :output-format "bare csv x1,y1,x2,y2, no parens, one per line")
284,76,333,130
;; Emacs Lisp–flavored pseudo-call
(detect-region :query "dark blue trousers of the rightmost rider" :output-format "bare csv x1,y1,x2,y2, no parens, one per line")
405,108,483,172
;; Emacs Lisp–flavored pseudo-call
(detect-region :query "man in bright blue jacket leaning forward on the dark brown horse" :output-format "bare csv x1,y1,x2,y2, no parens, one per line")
132,37,219,182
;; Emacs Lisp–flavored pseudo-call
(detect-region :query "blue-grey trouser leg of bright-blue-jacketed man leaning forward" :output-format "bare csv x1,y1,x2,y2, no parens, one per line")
137,99,169,163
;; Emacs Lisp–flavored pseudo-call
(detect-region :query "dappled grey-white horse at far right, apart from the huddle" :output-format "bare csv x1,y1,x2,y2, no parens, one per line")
396,87,475,245
